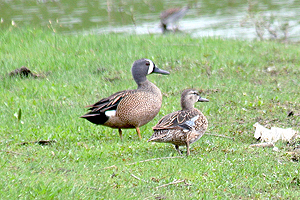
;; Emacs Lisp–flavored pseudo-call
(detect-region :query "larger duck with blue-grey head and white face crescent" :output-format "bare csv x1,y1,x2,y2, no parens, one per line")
81,59,169,140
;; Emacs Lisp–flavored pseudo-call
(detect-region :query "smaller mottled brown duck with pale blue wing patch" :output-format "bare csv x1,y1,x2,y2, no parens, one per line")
148,89,208,155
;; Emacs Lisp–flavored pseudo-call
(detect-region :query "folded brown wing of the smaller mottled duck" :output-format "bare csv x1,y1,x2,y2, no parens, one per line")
152,110,199,130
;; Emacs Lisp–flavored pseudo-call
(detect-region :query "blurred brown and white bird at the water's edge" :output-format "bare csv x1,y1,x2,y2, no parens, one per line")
160,6,189,33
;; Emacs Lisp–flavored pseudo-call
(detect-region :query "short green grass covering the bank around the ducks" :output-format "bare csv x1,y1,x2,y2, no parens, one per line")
0,28,300,199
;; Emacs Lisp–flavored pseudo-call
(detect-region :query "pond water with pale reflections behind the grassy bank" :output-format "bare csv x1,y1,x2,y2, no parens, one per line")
0,0,300,41
